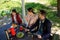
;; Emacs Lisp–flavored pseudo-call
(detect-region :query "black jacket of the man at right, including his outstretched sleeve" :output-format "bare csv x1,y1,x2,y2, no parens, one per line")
30,18,52,37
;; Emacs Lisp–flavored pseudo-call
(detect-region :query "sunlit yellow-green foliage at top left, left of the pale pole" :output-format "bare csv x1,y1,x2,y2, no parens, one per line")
0,0,21,16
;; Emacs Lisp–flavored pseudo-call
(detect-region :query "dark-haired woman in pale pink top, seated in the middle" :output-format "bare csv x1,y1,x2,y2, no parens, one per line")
26,8,38,26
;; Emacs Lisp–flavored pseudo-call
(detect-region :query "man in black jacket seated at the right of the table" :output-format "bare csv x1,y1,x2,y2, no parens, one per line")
36,10,52,40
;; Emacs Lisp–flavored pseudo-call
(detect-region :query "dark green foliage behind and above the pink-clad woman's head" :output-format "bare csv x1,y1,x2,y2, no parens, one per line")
25,3,49,12
